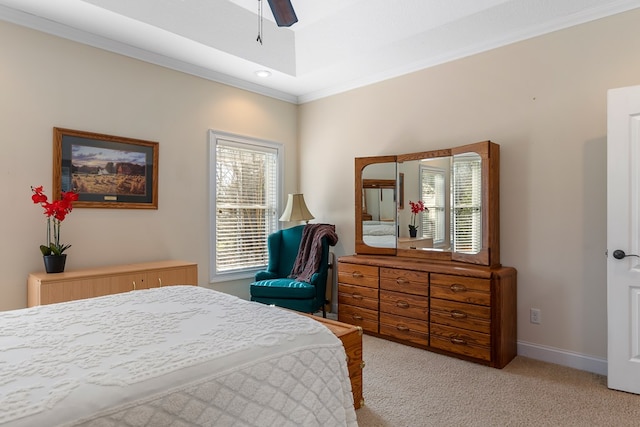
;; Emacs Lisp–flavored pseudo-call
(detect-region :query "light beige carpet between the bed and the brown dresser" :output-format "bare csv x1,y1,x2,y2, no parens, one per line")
356,335,640,427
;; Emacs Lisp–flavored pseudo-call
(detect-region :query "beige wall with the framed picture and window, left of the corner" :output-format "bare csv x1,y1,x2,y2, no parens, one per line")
0,22,297,310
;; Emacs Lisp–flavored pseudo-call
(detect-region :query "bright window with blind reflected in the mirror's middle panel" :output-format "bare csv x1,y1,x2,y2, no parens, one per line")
420,165,447,244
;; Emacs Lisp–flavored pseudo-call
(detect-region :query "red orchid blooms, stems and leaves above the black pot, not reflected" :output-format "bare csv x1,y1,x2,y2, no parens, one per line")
31,186,78,256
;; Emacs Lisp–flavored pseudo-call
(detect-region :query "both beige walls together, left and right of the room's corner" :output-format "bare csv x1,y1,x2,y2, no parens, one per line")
0,7,640,368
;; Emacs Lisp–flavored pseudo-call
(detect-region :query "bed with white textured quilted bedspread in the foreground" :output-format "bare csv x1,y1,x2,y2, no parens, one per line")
0,286,357,427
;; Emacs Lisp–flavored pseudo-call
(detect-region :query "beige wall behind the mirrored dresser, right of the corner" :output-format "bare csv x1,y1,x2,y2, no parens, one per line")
299,10,640,358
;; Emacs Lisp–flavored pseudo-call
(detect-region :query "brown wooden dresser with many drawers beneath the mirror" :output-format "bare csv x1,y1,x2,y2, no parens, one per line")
338,255,517,368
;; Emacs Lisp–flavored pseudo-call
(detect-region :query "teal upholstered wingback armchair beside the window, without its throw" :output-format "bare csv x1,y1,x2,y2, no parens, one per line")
250,224,337,317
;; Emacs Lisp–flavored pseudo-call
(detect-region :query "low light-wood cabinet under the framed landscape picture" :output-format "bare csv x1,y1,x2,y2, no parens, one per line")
27,261,198,307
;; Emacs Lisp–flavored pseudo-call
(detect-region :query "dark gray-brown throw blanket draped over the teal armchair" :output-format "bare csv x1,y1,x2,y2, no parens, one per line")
289,224,338,282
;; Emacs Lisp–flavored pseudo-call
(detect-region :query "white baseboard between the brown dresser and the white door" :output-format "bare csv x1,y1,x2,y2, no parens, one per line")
518,341,607,375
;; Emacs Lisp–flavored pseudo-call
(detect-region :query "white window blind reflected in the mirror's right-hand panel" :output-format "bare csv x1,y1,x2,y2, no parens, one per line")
452,155,482,254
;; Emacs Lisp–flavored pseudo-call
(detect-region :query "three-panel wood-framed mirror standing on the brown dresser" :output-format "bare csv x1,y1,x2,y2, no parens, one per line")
355,141,500,266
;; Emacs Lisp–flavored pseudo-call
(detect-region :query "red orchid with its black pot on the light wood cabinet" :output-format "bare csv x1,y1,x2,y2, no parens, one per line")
31,186,78,273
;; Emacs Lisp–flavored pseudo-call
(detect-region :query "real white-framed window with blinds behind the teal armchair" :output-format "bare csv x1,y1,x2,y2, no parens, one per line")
209,131,284,282
